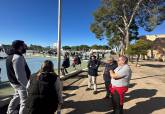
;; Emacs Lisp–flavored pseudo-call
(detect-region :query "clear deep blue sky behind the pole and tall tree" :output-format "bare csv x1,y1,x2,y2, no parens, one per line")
0,0,165,46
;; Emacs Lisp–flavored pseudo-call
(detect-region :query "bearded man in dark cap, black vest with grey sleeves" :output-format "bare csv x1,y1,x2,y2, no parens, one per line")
6,40,31,114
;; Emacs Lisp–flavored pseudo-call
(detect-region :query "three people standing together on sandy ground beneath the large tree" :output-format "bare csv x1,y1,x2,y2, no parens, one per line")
86,55,132,114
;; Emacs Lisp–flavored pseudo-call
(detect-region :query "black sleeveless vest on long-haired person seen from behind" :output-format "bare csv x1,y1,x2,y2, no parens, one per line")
26,73,58,114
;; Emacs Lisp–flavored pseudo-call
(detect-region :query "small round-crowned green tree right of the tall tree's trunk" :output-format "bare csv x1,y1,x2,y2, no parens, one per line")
126,39,153,66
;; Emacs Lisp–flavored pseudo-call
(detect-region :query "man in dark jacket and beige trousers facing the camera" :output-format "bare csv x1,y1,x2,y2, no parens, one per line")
86,56,99,94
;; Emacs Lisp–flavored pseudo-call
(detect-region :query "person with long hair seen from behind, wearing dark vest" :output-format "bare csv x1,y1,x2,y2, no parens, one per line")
26,60,63,114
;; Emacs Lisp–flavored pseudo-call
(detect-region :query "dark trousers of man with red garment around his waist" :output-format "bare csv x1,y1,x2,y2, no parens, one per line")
111,91,123,114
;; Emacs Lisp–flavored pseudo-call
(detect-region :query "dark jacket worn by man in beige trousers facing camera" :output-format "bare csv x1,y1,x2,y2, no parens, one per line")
88,60,99,76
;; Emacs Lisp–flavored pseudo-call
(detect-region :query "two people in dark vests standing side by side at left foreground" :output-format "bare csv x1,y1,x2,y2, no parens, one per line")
6,40,63,114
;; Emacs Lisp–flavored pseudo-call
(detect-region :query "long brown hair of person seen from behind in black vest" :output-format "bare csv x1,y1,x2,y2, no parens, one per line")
37,60,57,79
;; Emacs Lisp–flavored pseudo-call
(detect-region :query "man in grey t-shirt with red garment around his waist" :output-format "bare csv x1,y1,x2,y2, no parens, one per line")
110,56,132,114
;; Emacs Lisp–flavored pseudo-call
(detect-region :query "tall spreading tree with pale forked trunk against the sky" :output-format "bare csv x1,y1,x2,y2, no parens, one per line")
90,0,165,54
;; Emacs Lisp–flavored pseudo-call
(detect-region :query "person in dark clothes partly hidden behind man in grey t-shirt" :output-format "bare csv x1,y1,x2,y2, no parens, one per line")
103,57,117,98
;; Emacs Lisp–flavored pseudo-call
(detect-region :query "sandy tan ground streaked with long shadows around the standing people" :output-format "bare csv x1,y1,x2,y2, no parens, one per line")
62,62,165,114
